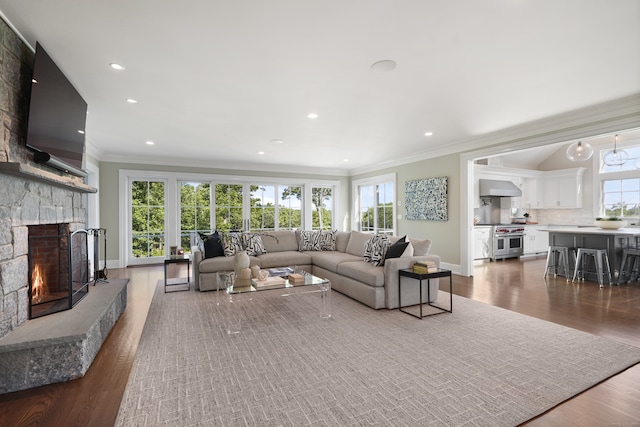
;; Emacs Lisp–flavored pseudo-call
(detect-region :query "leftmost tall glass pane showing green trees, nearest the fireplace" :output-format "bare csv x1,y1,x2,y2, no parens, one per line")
130,181,165,258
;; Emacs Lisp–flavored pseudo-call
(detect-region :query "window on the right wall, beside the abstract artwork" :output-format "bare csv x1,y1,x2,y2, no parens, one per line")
353,174,396,235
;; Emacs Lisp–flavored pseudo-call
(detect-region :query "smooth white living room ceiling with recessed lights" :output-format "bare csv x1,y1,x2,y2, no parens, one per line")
0,0,640,173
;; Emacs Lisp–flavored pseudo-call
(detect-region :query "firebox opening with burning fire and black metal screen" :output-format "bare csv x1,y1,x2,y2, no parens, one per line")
29,224,89,319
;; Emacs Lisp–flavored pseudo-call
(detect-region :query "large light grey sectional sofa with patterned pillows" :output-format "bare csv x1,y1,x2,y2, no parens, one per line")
192,231,440,309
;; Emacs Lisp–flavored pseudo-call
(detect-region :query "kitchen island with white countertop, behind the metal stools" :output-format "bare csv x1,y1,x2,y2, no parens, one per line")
540,226,640,277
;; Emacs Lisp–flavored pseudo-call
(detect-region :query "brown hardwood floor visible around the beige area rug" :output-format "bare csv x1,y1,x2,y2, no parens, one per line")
0,257,640,427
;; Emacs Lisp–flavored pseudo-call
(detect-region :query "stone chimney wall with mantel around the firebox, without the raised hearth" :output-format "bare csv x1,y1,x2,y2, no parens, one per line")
0,19,96,339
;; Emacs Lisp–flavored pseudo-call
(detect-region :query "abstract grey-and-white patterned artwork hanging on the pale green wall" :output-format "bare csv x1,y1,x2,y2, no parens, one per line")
405,176,448,221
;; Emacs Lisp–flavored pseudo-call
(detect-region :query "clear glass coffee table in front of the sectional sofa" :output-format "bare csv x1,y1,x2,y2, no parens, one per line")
217,272,331,334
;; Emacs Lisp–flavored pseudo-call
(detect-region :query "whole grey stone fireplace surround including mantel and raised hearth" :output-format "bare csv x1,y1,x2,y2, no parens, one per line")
0,18,127,393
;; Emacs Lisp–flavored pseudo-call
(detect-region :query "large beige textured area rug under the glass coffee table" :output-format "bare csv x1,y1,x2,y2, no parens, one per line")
116,284,640,427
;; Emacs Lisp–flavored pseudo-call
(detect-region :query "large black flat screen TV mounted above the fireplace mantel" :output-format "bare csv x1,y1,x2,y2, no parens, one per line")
27,43,87,176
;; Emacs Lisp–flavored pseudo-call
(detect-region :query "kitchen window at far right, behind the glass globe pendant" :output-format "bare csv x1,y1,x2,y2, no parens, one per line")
597,145,640,218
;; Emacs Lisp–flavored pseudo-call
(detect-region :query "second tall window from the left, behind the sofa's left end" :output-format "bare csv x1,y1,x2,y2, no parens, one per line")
180,181,211,253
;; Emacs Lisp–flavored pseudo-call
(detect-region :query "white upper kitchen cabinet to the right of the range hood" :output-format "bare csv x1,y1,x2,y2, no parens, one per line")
538,168,586,209
